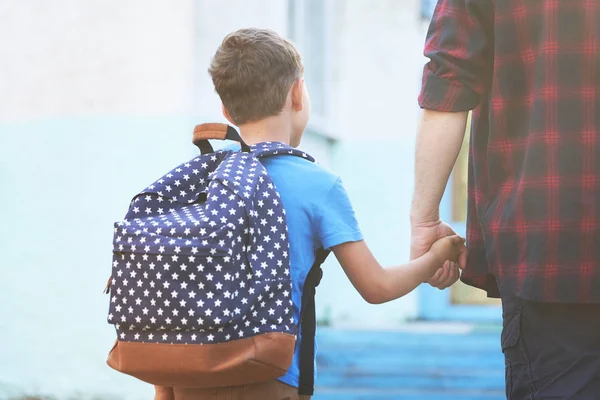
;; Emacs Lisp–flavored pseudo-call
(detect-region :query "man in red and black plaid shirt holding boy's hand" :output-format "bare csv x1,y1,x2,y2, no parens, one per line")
411,0,600,400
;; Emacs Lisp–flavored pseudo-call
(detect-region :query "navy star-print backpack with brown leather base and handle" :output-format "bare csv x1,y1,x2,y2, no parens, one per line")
106,124,328,395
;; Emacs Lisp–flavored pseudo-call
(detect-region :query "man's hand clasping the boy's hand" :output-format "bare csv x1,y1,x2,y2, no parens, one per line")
410,219,467,290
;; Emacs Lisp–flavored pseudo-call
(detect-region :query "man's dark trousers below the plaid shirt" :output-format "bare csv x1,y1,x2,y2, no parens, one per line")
501,293,600,400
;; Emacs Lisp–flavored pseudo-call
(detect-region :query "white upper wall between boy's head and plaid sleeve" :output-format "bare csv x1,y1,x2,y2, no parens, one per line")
332,0,424,140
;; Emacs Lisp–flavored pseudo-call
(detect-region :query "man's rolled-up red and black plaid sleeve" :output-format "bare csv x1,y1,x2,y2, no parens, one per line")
419,0,493,112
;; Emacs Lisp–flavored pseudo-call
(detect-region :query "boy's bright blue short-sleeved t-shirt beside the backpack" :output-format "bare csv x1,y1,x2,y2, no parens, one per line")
262,152,363,387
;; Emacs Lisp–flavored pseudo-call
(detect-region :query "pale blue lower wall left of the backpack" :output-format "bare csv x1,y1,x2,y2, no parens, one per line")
0,117,202,399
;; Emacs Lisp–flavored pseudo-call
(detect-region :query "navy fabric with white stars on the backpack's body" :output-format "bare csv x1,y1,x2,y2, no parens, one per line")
108,143,312,344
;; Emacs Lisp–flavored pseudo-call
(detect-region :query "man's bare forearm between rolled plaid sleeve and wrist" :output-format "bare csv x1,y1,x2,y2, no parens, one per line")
410,110,468,223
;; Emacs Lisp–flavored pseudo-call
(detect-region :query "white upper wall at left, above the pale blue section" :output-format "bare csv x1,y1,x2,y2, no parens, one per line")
0,0,194,121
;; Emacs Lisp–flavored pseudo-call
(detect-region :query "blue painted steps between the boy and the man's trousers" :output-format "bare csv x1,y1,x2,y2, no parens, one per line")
314,328,505,400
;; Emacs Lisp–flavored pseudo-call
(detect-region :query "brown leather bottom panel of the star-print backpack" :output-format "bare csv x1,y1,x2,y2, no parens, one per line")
107,332,295,388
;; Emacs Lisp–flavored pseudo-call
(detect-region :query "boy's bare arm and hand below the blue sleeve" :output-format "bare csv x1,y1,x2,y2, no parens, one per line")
332,236,464,304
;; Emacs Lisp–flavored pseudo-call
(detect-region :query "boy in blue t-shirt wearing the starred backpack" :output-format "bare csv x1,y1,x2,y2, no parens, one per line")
156,29,466,400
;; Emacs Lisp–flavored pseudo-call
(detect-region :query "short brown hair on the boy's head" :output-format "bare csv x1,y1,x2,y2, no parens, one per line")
208,28,304,125
